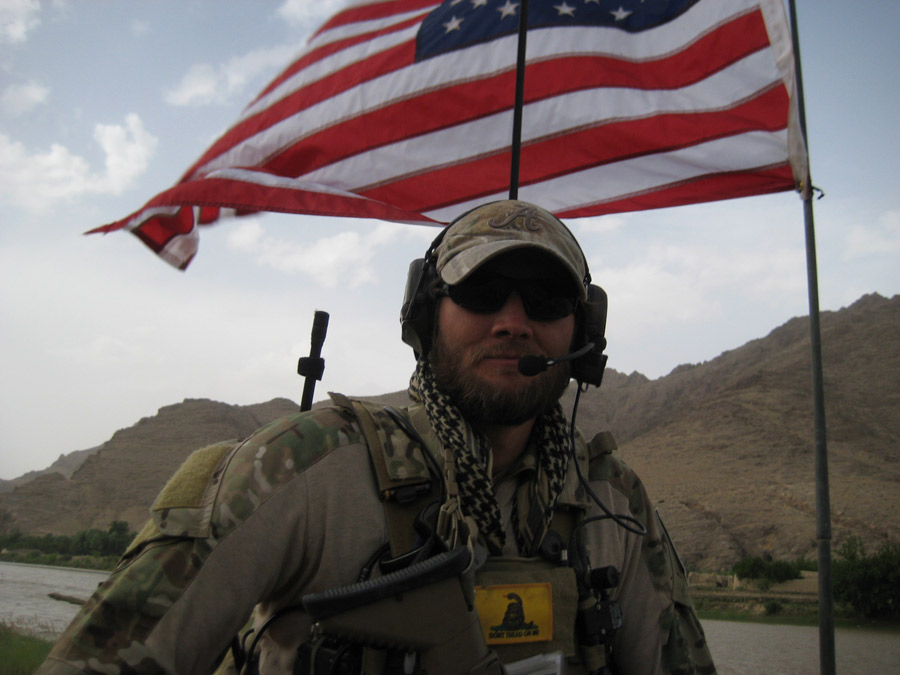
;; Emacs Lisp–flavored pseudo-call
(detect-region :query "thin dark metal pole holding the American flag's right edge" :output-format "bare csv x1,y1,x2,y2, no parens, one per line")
788,0,835,675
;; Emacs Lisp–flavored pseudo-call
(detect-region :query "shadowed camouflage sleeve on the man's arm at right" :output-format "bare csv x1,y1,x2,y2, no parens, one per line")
591,440,716,675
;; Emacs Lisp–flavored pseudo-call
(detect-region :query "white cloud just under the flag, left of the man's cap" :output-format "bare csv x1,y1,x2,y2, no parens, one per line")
227,219,410,288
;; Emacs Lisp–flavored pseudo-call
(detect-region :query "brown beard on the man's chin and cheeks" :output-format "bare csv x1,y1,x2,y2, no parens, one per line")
429,332,571,426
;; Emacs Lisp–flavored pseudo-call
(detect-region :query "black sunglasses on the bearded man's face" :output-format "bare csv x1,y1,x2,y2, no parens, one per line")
435,276,577,321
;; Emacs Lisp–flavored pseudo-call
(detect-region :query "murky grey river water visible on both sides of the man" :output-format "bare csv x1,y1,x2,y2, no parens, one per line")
0,562,900,675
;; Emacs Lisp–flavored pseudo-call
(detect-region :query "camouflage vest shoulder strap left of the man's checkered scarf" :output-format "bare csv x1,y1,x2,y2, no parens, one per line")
329,392,439,557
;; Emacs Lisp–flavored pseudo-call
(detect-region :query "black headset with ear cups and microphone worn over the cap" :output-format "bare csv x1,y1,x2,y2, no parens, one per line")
400,205,607,387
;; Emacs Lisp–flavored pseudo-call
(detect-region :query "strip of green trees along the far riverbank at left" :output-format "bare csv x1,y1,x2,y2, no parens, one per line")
0,520,135,569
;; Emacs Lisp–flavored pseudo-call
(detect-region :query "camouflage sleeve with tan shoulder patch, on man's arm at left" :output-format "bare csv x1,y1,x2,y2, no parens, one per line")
37,409,358,675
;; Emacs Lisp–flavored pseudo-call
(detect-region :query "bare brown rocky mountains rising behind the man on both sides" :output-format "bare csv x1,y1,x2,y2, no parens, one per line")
0,295,900,570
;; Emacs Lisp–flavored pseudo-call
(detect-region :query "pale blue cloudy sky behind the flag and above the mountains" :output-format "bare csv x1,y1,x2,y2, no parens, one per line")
0,0,900,478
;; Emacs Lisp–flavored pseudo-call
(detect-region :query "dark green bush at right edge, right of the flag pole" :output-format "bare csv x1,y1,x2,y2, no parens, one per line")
832,536,900,619
